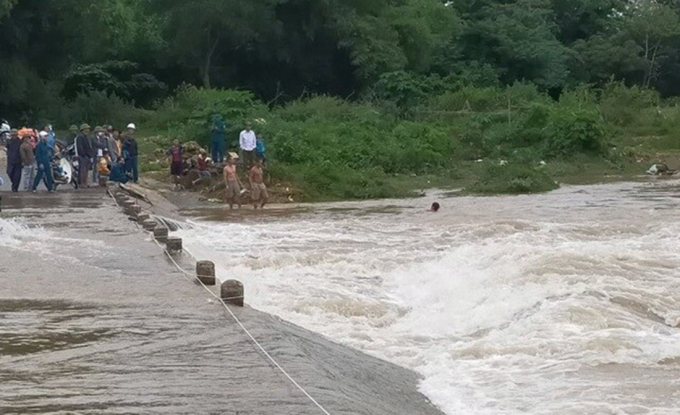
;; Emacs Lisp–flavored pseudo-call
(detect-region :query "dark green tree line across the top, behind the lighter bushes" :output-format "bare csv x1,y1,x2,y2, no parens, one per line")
0,0,680,119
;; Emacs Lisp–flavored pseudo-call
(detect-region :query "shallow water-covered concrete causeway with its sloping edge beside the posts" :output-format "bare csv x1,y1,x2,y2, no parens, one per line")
0,189,440,415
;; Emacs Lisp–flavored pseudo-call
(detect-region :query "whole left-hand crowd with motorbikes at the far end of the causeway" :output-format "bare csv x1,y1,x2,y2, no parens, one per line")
0,121,139,192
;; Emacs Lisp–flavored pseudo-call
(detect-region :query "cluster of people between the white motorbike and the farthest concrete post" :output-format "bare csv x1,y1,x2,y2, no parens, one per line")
70,123,139,187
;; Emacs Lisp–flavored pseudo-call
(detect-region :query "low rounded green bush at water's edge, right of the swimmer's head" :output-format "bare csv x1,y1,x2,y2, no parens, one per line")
467,163,559,194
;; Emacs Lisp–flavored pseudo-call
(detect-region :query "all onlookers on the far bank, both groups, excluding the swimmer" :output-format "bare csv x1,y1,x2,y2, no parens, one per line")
0,115,269,209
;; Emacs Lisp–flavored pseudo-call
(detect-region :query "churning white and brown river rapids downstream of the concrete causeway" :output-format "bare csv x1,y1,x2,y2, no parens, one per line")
180,181,680,415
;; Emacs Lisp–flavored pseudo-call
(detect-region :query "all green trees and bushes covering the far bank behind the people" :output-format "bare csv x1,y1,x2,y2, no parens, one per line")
0,0,680,200
